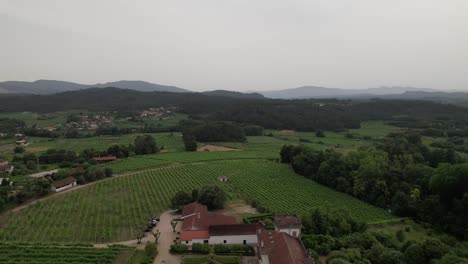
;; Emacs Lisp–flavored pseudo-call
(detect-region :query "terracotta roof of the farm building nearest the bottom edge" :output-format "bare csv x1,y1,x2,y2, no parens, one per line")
258,230,314,264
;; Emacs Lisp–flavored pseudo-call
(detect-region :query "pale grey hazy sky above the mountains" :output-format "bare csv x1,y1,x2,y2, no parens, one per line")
0,0,468,91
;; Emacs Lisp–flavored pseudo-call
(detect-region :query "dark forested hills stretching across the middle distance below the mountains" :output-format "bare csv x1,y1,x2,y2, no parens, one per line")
0,88,468,134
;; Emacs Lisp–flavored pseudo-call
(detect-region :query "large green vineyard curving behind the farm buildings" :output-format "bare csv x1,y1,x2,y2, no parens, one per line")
0,159,393,243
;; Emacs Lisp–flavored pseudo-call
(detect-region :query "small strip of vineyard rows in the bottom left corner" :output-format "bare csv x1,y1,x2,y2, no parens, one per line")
0,244,131,264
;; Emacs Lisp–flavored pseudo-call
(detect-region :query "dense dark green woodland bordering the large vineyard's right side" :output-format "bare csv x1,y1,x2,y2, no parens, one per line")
280,133,468,239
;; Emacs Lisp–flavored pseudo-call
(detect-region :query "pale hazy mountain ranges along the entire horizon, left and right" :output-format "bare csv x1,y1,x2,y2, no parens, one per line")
0,80,468,104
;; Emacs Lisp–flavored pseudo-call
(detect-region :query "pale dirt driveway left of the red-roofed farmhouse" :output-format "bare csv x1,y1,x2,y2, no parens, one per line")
153,211,182,264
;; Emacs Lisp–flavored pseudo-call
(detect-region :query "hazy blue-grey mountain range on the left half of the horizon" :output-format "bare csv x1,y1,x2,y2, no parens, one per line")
0,80,190,94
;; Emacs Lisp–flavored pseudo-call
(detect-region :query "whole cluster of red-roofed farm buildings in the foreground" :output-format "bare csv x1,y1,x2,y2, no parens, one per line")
179,202,314,264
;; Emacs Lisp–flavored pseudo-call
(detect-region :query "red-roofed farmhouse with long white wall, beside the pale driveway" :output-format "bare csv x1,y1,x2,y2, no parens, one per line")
180,203,259,245
